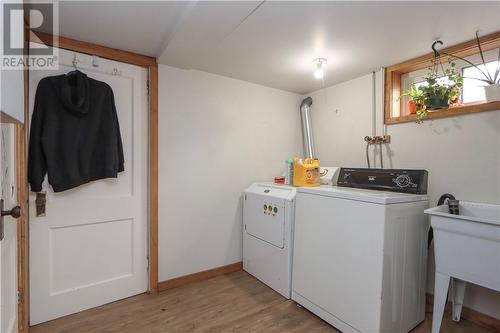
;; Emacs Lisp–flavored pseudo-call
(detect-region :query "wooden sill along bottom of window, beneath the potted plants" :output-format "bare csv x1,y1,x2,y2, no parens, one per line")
385,101,500,125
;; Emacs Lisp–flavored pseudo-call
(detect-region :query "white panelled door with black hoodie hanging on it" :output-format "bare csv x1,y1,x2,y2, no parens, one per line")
29,50,148,325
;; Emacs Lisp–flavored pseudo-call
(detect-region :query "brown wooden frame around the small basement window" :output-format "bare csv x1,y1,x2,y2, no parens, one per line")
384,31,500,125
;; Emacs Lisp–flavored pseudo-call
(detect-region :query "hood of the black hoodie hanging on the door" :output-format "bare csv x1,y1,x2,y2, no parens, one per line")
60,70,90,117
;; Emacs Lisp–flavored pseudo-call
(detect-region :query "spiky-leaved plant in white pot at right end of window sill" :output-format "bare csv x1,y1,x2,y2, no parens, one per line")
432,31,500,103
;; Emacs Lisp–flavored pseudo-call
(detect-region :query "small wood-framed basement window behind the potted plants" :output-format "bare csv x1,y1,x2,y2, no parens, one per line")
384,31,500,124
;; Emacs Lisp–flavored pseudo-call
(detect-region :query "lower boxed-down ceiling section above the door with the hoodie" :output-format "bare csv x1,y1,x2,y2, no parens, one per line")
53,1,188,57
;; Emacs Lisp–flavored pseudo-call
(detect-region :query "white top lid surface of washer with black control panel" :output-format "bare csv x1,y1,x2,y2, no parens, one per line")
297,186,428,205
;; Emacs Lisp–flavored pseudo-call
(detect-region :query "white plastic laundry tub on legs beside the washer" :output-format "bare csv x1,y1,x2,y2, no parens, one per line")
425,202,500,333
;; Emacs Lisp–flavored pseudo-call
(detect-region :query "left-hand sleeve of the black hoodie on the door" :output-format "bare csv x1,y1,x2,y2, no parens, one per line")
28,80,47,192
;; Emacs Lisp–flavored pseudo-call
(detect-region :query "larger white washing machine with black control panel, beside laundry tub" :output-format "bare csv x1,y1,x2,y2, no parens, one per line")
292,170,429,333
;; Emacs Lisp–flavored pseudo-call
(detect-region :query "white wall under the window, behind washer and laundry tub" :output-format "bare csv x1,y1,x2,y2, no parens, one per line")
308,73,500,319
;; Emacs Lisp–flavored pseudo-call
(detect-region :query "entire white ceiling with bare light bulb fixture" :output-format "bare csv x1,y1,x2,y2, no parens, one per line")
52,1,500,94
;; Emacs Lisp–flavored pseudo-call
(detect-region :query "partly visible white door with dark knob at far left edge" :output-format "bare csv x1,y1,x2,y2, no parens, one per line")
0,124,17,333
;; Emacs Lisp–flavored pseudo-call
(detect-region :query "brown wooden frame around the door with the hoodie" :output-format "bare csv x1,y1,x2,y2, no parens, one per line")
16,32,158,333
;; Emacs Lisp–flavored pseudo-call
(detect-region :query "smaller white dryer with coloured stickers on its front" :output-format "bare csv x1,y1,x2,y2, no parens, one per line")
243,183,297,298
